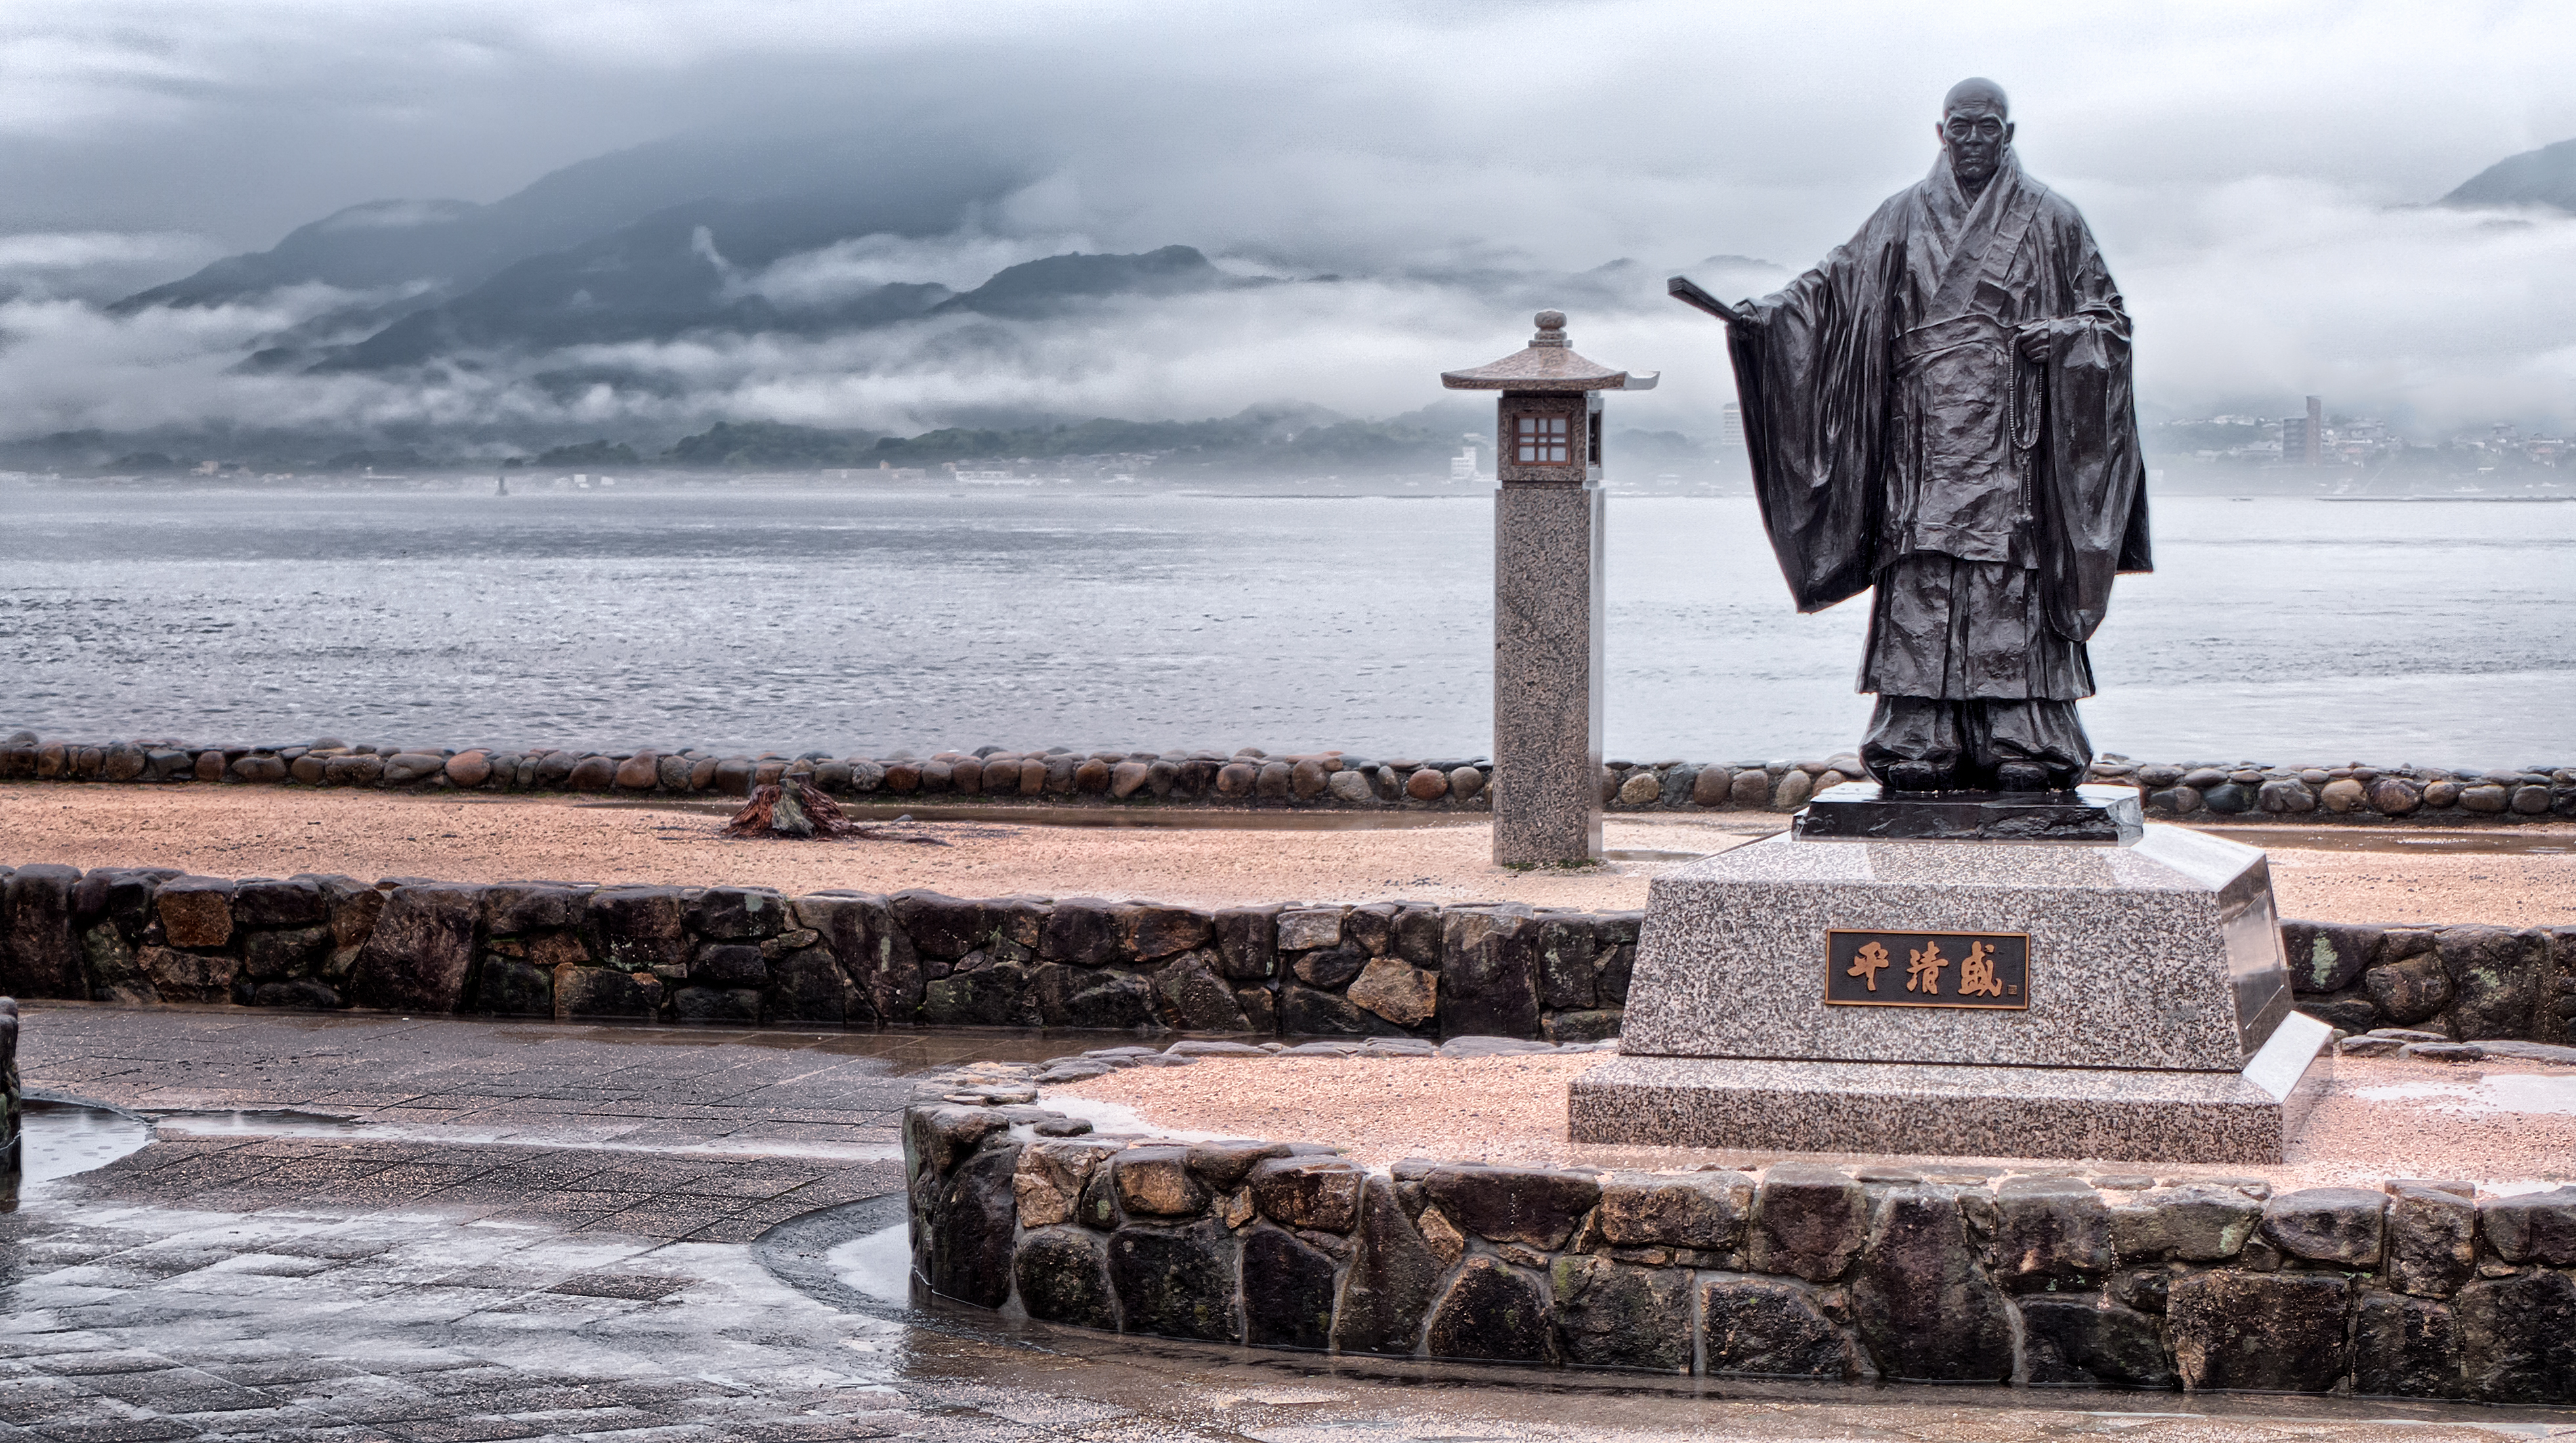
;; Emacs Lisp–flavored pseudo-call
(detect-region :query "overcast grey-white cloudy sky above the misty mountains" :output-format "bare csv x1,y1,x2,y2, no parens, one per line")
0,0,2576,441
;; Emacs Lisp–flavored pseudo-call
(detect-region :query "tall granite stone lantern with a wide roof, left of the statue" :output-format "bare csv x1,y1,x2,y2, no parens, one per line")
1440,312,1657,866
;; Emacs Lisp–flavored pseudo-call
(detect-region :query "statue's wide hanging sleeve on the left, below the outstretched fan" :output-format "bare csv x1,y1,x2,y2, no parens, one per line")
1726,201,1901,611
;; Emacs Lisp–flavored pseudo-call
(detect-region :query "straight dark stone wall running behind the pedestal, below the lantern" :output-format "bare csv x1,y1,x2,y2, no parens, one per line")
0,863,2576,1044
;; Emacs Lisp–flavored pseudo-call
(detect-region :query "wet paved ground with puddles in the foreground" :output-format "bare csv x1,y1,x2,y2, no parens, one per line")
0,1008,2576,1443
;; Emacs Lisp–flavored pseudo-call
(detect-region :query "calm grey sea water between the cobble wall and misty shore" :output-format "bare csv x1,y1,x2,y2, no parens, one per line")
0,485,2576,765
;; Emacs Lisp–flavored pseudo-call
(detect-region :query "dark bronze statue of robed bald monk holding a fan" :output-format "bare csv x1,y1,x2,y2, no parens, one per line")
1726,80,2148,791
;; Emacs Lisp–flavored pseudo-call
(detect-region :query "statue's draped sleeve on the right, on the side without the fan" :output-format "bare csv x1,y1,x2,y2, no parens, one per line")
2033,214,2151,641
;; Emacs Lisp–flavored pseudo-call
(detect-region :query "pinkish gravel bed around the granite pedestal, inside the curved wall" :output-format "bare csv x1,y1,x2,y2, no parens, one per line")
1044,1054,2576,1188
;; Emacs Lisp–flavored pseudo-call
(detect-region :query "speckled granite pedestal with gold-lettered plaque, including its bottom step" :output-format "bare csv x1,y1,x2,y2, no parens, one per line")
1569,827,2331,1162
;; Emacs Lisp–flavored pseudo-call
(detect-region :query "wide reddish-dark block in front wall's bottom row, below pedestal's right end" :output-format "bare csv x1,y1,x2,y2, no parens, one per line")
2164,1268,2352,1394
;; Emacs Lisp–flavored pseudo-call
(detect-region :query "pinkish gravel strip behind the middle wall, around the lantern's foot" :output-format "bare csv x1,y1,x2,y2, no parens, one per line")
0,783,2576,928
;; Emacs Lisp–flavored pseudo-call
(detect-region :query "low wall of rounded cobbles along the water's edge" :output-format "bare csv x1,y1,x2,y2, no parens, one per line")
0,732,2576,825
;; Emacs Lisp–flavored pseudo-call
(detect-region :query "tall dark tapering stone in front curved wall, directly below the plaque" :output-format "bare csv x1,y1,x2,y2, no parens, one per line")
1852,1183,2014,1384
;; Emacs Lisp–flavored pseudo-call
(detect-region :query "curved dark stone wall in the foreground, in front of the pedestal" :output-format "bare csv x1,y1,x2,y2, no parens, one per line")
904,1059,2576,1402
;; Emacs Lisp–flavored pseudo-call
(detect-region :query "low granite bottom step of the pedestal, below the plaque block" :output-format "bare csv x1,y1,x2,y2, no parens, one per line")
1566,1015,2334,1162
